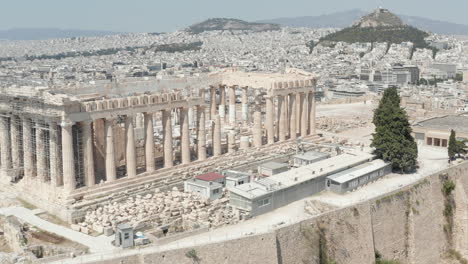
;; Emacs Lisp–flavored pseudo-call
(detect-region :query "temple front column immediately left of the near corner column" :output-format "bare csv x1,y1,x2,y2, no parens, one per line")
49,122,63,187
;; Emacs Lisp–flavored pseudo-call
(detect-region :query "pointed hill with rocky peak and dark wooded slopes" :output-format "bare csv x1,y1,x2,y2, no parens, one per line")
319,8,429,48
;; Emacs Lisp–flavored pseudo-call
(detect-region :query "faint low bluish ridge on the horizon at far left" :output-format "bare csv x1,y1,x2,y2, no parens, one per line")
0,28,119,40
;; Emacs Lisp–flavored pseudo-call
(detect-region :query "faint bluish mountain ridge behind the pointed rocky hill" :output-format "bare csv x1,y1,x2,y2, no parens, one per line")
256,9,468,35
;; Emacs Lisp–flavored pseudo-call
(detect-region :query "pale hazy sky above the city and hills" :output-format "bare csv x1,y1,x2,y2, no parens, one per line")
0,0,468,32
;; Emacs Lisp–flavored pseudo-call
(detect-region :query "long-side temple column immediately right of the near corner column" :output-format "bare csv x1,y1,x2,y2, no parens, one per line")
81,120,96,187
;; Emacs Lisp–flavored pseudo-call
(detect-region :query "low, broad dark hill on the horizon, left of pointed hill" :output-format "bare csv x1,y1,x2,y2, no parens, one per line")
186,18,281,34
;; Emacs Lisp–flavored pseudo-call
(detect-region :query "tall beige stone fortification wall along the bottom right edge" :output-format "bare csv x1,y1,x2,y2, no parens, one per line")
75,162,468,264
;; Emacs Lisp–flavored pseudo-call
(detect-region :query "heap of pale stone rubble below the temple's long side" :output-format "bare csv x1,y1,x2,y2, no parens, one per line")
82,187,247,233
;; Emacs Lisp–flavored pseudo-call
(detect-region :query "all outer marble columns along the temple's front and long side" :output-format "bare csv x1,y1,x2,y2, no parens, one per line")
0,86,315,191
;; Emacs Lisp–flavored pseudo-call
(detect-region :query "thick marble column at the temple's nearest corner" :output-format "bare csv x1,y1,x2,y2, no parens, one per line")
61,120,76,192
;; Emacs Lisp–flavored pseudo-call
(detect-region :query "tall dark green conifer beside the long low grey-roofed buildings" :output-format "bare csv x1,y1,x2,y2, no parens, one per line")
371,87,418,172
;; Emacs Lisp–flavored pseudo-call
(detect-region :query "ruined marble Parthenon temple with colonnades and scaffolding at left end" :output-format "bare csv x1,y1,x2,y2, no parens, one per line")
0,71,316,221
